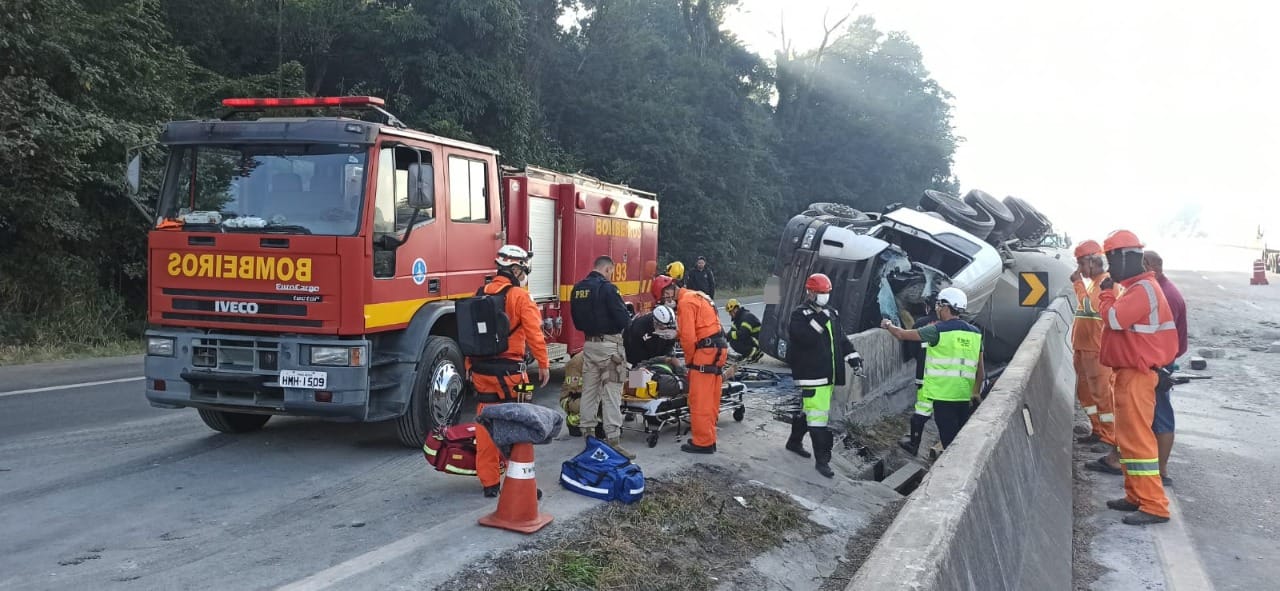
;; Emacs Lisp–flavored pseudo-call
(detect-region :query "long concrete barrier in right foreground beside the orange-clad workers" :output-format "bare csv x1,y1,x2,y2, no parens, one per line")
847,298,1075,591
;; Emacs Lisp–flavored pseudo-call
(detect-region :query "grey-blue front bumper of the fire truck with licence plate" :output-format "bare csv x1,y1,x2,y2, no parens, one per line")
145,329,370,421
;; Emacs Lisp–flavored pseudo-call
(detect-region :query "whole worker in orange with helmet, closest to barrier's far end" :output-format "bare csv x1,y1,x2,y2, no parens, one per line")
1071,240,1116,445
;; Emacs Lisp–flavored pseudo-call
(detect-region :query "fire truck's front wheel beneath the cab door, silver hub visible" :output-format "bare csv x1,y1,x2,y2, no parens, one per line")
396,336,466,449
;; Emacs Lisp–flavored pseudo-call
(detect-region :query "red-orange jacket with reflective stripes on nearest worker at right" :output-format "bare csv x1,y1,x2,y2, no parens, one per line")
1098,272,1178,370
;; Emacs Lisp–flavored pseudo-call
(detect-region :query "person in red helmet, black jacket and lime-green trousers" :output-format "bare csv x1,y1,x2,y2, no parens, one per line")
786,272,863,478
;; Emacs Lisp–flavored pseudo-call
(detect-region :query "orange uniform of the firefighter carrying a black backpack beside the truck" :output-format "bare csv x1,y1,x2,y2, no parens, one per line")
466,272,550,489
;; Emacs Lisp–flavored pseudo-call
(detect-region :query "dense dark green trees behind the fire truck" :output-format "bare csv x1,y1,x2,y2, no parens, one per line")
0,0,957,344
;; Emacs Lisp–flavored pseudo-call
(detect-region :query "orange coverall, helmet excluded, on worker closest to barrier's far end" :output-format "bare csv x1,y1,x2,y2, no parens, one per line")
1071,272,1116,445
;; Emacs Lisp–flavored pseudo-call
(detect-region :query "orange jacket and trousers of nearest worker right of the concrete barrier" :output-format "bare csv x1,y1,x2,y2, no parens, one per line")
1098,271,1178,518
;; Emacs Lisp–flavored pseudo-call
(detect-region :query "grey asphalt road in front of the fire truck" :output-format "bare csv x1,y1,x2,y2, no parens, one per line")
0,298,760,590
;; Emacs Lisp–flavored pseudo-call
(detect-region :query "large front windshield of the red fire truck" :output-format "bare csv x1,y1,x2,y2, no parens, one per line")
157,143,366,235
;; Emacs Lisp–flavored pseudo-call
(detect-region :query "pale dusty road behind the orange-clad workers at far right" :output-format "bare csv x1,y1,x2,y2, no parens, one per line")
1166,268,1280,590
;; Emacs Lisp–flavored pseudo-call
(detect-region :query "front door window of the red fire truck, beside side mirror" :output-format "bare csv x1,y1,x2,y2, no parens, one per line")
374,146,435,278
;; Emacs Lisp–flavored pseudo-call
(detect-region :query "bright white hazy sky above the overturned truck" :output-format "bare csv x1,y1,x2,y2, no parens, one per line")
727,0,1280,242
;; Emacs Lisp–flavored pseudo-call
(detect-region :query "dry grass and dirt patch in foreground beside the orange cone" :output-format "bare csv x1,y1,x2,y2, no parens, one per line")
436,464,826,591
